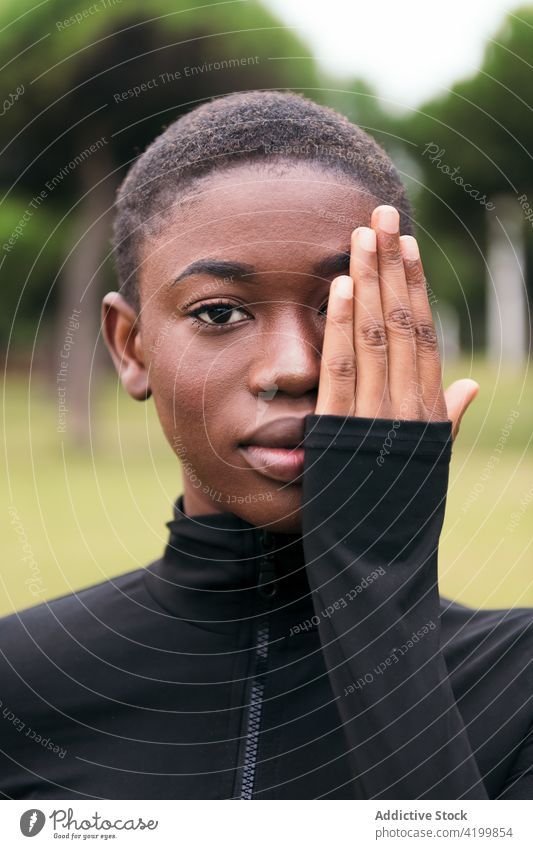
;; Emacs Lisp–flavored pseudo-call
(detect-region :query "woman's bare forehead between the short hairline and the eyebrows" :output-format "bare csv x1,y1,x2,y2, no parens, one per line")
140,162,377,288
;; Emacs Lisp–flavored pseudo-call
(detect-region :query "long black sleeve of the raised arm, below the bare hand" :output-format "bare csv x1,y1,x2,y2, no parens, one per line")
302,415,488,799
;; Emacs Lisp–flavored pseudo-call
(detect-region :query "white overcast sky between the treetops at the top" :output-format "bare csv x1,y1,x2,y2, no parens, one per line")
263,0,533,109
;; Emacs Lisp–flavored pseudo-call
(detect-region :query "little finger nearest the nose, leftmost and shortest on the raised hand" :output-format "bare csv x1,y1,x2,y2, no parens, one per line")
315,275,355,416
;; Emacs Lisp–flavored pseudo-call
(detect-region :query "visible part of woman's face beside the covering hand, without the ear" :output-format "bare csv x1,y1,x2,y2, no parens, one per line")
128,163,378,532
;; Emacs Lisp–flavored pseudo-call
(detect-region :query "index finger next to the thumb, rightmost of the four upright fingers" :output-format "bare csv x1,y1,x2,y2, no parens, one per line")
400,236,447,421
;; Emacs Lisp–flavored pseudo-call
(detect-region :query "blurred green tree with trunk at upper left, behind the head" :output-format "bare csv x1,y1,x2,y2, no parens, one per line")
0,0,316,442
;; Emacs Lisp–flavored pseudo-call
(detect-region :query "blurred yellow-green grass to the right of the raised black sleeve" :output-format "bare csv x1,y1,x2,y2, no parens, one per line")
439,363,533,607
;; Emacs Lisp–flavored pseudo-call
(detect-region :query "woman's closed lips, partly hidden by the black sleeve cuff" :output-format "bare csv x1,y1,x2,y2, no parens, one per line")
239,416,305,483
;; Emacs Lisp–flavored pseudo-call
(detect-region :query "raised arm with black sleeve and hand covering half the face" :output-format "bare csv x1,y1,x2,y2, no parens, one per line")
302,206,487,799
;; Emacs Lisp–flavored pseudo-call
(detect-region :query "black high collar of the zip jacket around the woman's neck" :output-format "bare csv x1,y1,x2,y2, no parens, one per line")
145,495,312,630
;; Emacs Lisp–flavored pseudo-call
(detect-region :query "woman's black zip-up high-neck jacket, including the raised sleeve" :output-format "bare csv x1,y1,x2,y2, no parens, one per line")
0,415,533,799
